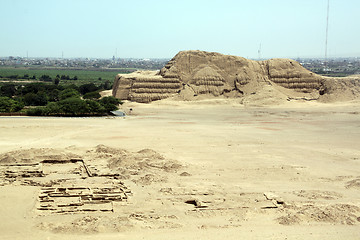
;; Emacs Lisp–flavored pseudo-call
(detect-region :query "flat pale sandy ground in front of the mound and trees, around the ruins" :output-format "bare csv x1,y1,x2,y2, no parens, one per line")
0,100,360,239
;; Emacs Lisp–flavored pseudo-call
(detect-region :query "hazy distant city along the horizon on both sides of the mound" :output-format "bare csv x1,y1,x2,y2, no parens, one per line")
0,56,360,76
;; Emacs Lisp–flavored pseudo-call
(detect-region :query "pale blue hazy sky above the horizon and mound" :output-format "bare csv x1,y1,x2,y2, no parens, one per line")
0,0,360,58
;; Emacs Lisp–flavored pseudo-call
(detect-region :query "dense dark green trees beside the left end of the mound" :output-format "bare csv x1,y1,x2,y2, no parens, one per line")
0,83,121,116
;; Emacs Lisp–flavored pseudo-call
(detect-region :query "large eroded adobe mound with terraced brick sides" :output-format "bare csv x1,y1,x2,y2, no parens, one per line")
113,51,358,103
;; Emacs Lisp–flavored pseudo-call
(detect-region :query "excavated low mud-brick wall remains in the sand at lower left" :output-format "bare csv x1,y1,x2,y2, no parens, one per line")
0,159,131,214
